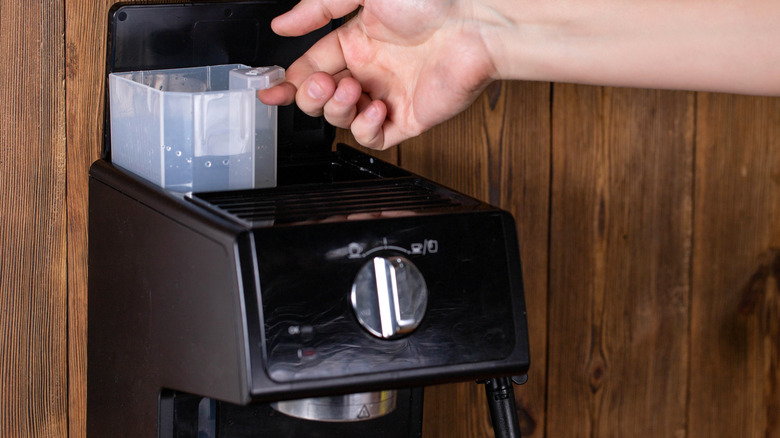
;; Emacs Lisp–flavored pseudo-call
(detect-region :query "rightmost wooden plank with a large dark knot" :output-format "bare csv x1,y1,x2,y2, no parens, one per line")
689,94,780,438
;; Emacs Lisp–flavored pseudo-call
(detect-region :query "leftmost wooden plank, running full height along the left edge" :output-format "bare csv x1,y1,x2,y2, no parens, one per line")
0,0,68,438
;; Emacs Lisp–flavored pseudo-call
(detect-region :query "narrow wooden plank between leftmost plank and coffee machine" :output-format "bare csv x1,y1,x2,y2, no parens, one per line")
65,0,113,438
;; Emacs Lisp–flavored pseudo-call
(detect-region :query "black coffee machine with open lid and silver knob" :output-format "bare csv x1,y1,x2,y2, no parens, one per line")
87,0,529,438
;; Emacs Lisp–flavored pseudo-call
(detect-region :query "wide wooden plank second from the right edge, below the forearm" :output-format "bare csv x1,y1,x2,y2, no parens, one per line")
547,84,694,437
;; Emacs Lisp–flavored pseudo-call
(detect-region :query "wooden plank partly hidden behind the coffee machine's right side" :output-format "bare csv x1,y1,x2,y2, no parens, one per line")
399,82,550,437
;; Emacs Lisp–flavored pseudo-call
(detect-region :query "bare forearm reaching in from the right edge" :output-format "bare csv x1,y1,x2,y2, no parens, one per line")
474,0,780,94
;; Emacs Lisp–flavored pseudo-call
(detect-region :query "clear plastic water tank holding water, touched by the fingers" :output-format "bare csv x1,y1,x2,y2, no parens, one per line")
109,64,284,192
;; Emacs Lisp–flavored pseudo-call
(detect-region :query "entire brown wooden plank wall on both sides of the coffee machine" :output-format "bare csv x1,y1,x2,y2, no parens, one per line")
0,0,780,438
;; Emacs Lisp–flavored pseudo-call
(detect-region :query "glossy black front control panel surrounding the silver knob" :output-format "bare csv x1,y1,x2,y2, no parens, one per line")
253,212,524,383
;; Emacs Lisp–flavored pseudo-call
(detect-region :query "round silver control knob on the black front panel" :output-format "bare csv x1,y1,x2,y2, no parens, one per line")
350,256,428,339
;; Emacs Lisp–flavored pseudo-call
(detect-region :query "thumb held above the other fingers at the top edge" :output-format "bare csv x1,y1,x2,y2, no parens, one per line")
271,0,363,36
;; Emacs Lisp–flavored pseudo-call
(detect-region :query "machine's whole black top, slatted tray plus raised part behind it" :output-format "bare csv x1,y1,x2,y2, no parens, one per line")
190,148,476,226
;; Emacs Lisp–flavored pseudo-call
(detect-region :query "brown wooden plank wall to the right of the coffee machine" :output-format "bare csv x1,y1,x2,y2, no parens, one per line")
342,82,780,438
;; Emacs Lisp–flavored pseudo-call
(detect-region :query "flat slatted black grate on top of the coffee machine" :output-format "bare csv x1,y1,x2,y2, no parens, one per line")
192,178,473,224
